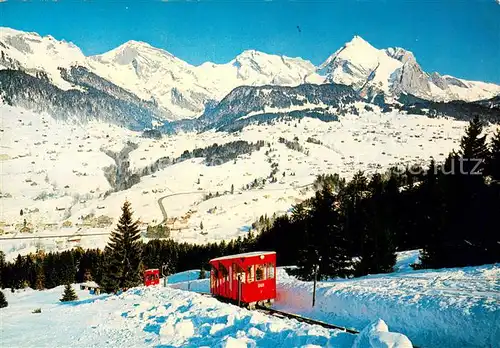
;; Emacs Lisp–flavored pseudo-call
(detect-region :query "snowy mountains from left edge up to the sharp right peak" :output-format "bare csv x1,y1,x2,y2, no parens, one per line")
0,28,321,120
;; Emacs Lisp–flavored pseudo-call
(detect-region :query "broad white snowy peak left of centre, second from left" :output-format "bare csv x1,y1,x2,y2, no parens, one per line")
87,41,211,119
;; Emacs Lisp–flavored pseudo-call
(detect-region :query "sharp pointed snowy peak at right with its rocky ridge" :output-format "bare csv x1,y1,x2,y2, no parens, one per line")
318,36,500,101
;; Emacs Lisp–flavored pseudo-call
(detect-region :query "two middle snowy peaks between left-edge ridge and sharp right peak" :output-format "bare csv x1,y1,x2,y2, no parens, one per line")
88,45,315,119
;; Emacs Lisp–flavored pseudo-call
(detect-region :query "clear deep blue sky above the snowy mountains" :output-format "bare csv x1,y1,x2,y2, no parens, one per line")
0,0,500,83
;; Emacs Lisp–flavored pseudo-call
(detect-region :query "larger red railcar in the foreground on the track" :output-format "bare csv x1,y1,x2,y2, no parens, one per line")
210,251,276,308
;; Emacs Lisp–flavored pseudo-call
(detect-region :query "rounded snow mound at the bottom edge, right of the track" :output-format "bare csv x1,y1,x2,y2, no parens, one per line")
352,319,413,348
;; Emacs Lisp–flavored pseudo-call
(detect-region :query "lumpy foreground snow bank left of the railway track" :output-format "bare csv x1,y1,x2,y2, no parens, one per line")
0,286,355,348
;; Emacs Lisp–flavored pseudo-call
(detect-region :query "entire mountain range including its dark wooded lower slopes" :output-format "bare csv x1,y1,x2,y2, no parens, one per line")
0,28,500,132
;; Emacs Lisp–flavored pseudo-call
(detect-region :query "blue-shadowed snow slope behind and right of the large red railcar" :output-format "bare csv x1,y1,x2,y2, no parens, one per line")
171,251,500,348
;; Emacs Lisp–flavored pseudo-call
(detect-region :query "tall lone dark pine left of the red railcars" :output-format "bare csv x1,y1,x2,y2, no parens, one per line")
100,201,143,293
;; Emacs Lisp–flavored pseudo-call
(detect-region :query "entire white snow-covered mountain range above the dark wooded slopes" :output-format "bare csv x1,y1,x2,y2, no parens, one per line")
0,28,500,120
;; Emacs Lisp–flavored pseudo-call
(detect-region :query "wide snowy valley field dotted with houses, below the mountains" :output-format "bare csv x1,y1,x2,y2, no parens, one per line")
0,105,494,259
